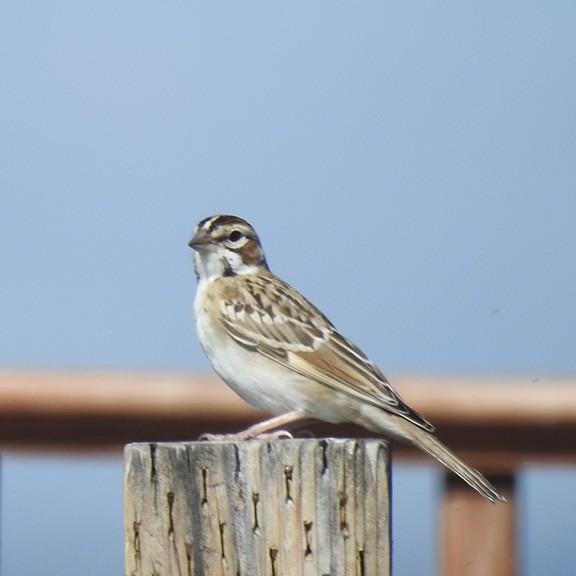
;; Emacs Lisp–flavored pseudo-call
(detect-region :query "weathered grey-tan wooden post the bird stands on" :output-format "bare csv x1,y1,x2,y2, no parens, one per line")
124,439,390,576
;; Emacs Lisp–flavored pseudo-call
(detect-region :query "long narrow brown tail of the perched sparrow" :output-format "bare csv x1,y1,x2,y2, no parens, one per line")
407,426,506,502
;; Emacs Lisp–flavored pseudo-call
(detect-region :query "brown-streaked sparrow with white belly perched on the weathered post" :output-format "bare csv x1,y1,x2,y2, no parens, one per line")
188,214,505,503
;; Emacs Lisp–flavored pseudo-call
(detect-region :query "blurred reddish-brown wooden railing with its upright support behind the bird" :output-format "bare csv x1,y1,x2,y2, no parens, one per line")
0,372,576,576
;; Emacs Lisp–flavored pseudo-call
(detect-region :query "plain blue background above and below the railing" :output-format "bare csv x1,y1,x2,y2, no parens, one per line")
0,0,576,576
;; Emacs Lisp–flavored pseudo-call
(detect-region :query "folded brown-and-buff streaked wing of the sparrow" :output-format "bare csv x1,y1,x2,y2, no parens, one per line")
221,275,434,432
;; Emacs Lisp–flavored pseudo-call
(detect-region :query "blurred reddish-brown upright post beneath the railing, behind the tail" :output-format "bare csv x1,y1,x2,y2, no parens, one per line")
441,475,516,576
